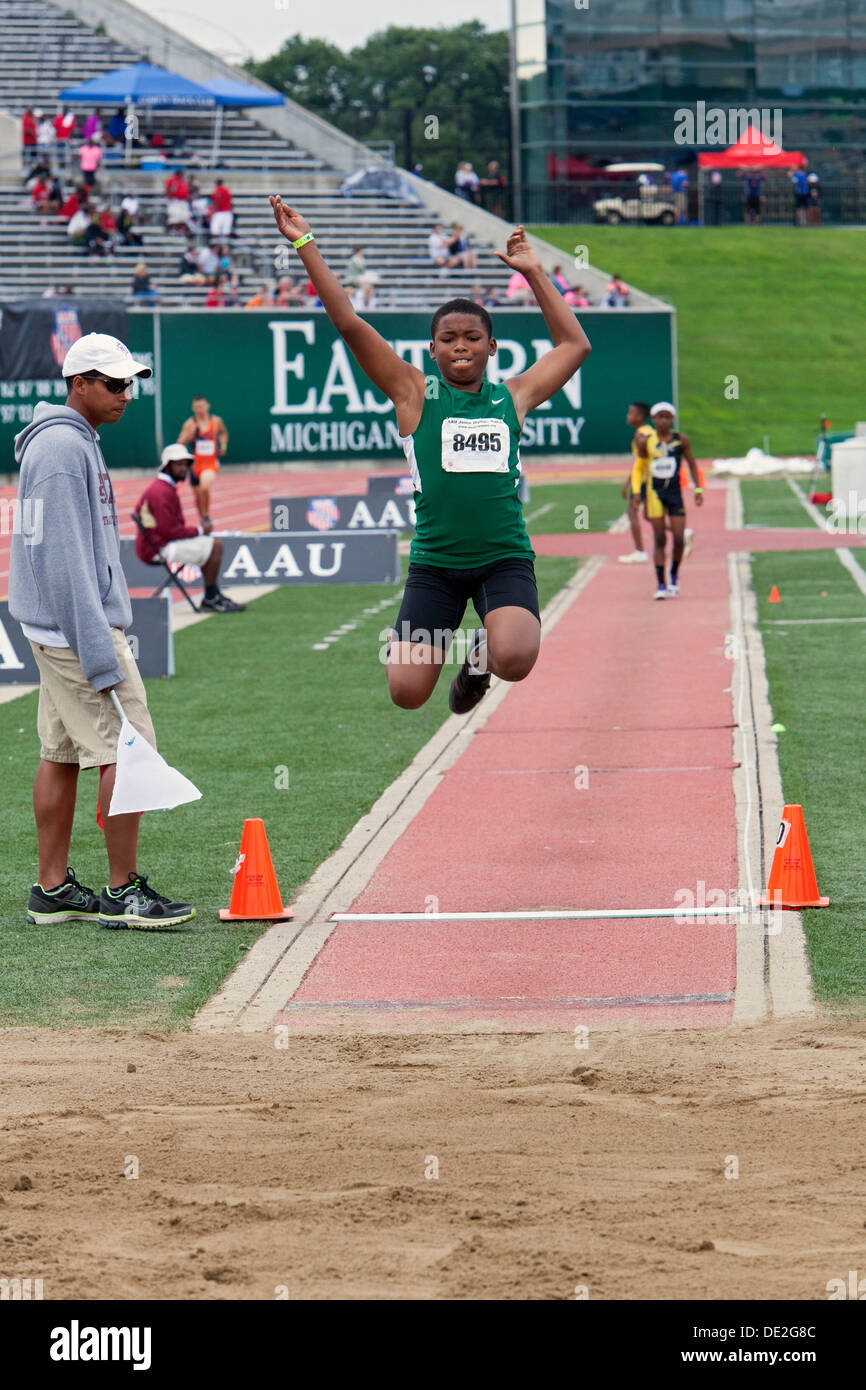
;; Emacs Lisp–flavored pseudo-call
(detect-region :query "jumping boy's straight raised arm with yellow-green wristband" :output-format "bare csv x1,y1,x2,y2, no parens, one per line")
271,195,424,419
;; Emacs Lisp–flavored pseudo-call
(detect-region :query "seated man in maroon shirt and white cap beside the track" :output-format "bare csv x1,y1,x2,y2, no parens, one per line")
135,443,246,613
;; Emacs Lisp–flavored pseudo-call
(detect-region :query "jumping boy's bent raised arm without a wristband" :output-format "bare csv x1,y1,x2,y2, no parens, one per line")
496,227,592,424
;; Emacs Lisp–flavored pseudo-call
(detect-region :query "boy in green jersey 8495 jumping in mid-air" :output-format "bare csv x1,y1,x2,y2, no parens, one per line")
271,197,589,714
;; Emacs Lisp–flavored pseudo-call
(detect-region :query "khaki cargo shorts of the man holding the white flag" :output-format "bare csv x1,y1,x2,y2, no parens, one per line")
31,627,156,767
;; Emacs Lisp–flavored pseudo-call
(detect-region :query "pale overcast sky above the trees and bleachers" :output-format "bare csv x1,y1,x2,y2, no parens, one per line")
132,0,510,63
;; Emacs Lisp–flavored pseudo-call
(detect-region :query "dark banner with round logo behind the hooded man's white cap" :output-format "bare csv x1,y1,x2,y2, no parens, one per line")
0,299,126,380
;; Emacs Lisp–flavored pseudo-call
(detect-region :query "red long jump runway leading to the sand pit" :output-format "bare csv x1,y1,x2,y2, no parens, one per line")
277,489,742,1031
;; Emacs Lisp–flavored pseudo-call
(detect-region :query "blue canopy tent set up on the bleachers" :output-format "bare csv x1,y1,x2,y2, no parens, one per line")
60,63,285,163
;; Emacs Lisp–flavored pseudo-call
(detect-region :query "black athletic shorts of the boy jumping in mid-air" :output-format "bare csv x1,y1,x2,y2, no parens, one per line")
395,556,539,648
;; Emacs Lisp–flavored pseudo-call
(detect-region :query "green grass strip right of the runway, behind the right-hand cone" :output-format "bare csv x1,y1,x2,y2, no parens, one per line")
752,550,866,1005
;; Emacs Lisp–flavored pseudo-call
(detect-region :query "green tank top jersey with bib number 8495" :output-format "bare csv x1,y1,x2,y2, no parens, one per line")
400,377,535,570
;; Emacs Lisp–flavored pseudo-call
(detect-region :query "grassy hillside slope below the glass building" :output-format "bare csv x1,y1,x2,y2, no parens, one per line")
531,225,866,457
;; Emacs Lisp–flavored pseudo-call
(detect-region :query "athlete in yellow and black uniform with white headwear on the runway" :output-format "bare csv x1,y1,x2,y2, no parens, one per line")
638,400,703,599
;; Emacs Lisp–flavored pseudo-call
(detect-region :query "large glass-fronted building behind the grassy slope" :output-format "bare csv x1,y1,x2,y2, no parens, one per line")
512,0,866,222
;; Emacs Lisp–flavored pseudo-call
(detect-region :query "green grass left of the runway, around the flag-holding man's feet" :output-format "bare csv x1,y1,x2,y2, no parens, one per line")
0,557,575,1027
